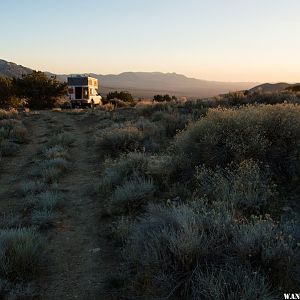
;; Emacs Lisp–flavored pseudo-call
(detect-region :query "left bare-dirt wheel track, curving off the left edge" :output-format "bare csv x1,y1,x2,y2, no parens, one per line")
0,114,48,213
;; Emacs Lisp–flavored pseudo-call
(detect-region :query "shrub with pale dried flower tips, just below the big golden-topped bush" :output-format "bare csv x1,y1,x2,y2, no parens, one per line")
195,160,274,214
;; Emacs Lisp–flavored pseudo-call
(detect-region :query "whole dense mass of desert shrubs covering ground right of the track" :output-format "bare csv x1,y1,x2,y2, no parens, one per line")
99,99,300,300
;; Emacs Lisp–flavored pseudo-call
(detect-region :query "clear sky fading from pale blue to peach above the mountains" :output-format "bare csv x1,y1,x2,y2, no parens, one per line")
0,0,300,82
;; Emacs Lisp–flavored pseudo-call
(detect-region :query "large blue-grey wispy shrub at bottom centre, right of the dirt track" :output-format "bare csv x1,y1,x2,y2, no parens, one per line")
120,205,231,299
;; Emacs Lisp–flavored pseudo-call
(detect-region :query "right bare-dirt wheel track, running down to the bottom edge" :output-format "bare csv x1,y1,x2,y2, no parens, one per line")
42,113,112,300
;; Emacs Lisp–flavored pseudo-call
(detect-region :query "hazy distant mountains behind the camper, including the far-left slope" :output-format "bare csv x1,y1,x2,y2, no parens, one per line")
0,60,257,98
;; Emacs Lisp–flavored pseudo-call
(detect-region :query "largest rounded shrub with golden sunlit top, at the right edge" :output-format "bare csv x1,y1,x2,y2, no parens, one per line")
175,104,300,180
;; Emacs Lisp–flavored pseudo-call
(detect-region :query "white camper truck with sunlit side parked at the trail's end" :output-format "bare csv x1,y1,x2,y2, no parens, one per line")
68,76,102,108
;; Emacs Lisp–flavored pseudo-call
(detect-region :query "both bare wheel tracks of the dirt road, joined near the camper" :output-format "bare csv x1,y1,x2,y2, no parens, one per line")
0,111,115,300
